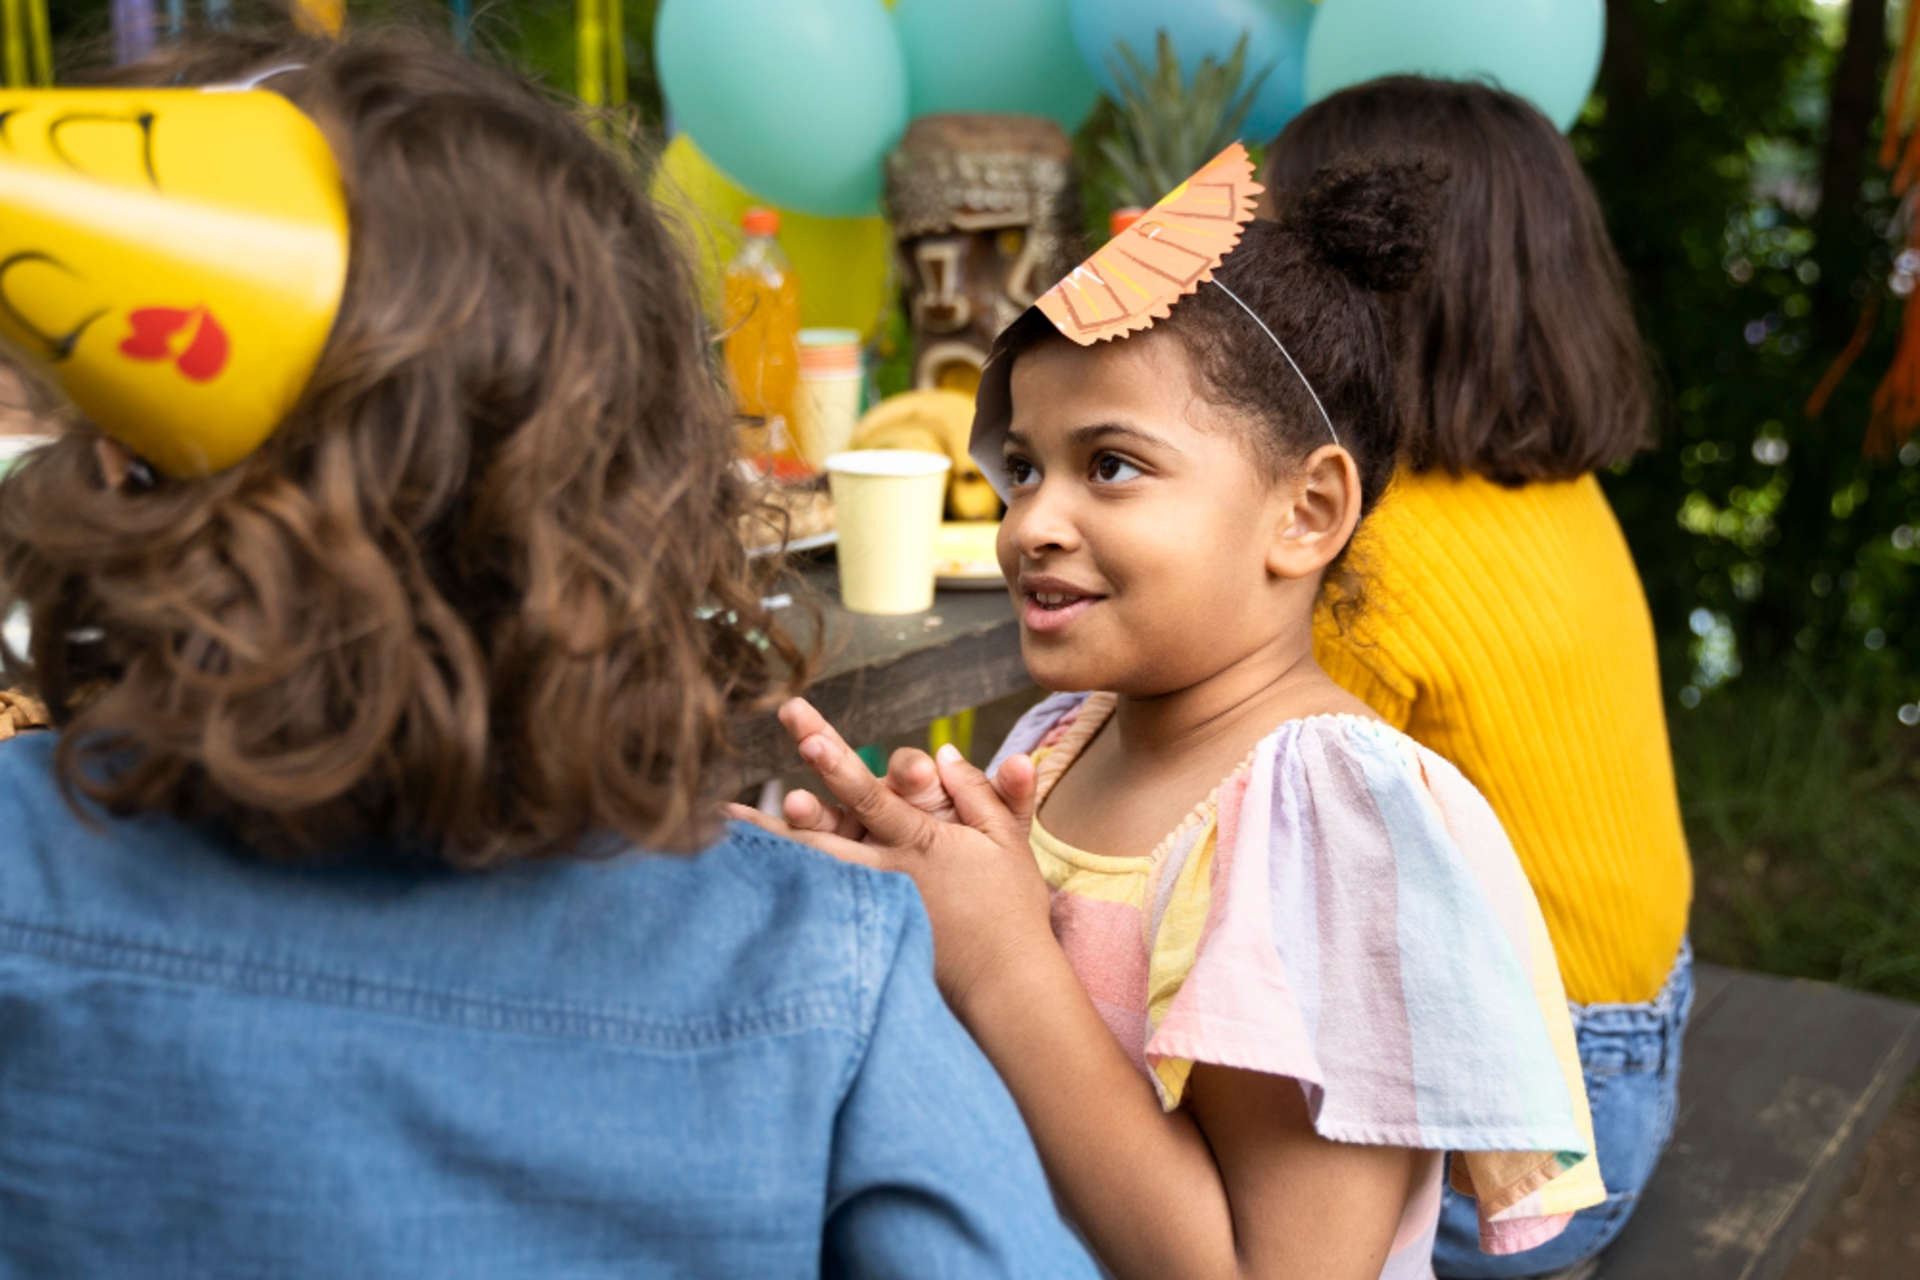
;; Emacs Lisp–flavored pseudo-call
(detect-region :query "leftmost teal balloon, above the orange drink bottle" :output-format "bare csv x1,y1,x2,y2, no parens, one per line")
653,0,906,217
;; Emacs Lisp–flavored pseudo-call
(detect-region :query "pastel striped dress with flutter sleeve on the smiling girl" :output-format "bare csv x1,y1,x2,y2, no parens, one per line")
995,693,1605,1280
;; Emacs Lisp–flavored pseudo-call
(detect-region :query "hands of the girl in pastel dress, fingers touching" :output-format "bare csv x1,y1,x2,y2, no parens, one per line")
730,699,1054,1019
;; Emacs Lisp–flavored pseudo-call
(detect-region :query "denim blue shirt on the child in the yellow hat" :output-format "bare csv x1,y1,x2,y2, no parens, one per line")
0,733,1094,1278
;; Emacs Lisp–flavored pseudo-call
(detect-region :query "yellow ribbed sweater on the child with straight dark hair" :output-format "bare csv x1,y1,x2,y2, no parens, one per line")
1315,472,1693,1004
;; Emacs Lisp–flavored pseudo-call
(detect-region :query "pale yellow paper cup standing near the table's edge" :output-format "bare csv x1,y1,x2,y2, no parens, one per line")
826,449,952,614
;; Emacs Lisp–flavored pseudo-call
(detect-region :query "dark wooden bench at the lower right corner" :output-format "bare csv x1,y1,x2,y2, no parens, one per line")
1592,965,1920,1280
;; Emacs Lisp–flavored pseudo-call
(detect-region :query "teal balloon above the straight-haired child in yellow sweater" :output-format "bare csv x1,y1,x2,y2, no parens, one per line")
1308,0,1607,130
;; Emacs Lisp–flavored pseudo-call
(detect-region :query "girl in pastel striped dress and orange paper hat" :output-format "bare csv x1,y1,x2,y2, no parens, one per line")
739,148,1603,1280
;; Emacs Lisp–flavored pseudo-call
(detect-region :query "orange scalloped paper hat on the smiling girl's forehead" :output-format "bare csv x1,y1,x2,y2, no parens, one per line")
968,142,1263,499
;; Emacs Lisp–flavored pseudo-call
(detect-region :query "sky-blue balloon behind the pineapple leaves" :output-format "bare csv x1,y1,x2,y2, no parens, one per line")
1071,0,1320,142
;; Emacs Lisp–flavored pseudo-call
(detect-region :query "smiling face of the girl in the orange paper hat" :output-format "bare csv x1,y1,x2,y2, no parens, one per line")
998,330,1317,697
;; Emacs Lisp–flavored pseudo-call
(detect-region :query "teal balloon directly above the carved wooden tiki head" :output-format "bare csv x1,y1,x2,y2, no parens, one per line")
893,0,1100,132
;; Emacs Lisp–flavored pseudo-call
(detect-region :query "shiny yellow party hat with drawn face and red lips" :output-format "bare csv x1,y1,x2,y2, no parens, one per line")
0,88,348,476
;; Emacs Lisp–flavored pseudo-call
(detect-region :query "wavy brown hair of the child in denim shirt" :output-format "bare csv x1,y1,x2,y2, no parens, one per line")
0,33,806,867
